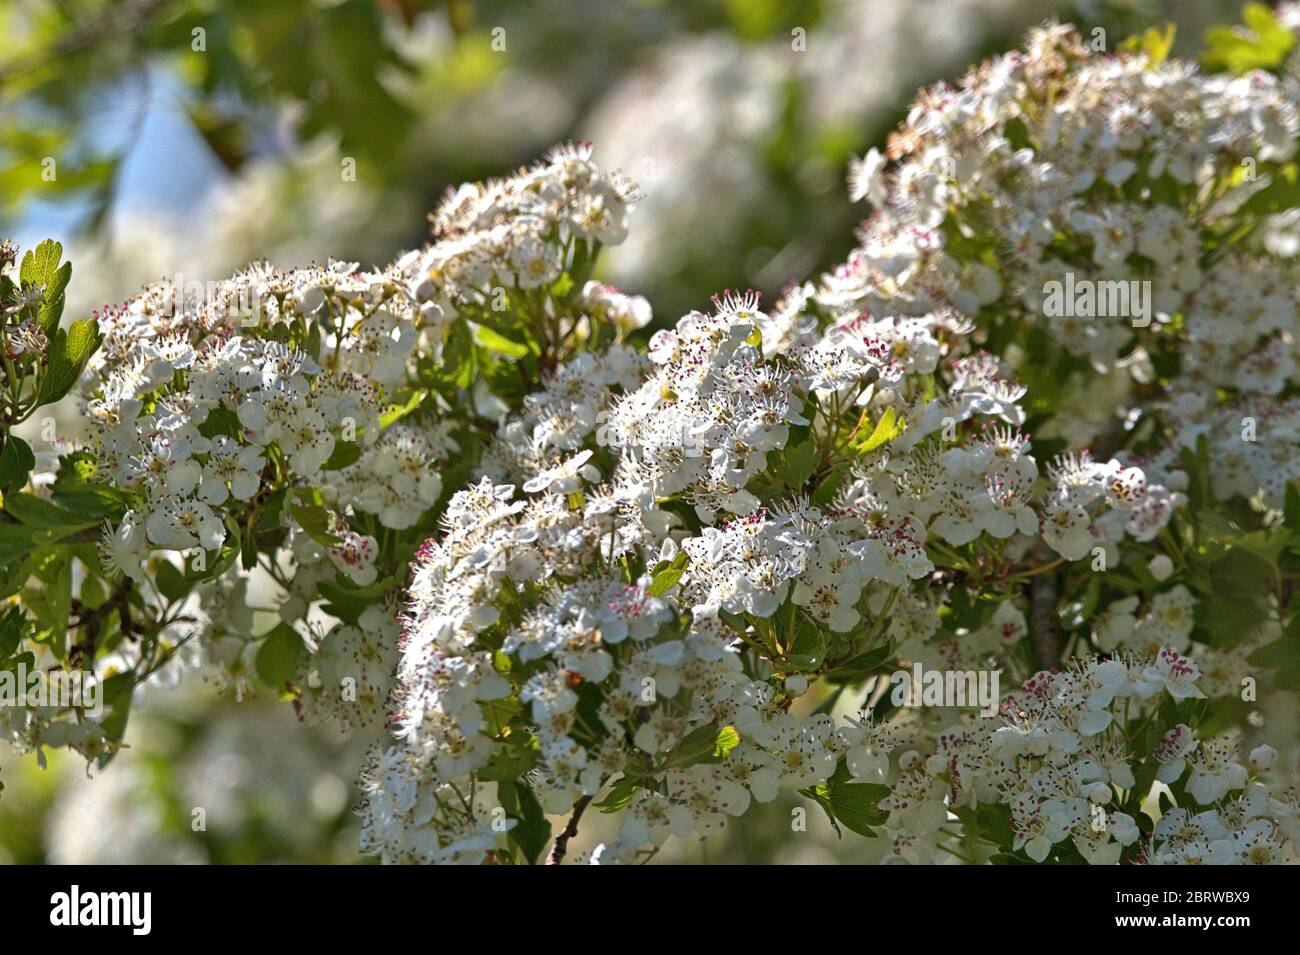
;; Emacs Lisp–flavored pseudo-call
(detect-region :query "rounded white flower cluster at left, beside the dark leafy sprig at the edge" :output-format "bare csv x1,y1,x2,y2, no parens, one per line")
86,257,419,574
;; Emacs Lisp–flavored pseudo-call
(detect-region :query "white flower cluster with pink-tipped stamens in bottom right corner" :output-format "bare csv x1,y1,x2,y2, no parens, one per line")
880,648,1300,865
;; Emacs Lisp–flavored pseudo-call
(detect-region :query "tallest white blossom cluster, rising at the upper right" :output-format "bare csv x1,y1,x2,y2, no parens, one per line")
818,26,1300,493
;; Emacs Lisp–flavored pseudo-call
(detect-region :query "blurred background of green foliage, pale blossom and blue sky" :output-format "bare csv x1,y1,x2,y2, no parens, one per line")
0,0,1258,863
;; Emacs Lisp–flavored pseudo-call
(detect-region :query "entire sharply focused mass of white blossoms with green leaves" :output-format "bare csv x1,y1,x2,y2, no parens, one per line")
5,14,1300,864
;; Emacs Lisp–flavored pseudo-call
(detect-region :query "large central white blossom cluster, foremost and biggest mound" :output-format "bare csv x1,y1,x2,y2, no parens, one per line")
365,272,1201,861
